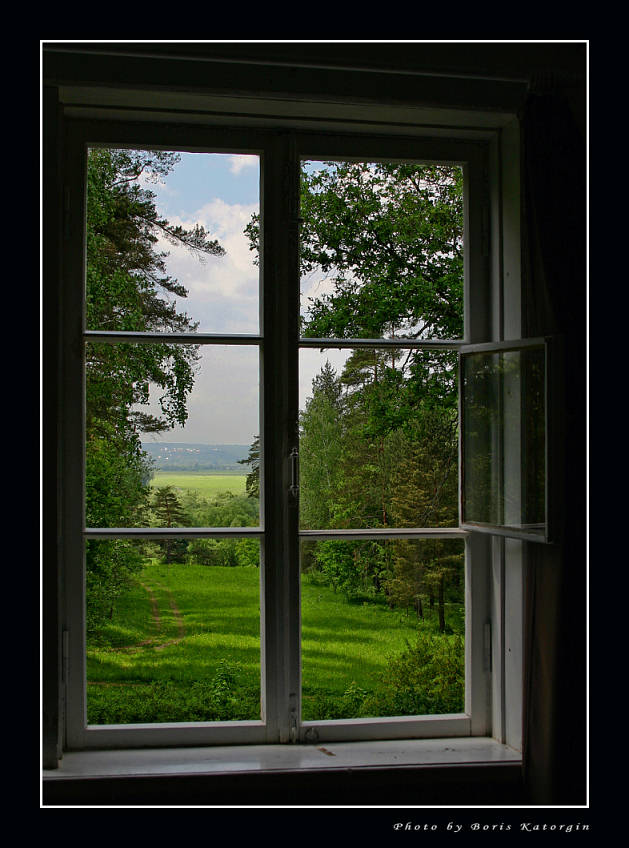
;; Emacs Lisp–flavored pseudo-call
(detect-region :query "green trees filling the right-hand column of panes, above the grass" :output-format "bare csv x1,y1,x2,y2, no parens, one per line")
292,162,463,632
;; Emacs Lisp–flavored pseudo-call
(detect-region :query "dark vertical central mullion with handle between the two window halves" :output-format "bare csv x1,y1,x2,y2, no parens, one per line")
261,134,300,742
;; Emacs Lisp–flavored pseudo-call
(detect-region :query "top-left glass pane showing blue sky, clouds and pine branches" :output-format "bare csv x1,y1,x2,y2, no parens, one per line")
86,148,260,333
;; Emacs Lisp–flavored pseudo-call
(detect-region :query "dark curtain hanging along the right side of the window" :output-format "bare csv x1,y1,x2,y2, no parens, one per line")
521,81,587,805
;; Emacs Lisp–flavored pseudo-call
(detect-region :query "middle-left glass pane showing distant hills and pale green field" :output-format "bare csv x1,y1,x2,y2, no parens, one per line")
85,342,259,527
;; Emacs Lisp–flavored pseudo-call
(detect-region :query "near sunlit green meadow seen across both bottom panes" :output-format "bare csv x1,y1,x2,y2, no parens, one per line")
87,562,430,724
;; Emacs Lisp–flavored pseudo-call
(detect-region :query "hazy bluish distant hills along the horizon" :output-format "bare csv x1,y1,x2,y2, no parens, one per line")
142,442,251,474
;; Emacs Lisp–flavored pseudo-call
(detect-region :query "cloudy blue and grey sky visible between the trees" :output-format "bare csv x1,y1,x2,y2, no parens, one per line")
135,153,348,445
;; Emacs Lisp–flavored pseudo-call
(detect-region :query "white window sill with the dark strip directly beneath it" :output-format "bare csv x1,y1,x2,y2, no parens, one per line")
42,737,524,807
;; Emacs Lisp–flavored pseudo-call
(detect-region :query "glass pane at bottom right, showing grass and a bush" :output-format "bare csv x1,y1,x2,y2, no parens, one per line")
301,539,465,721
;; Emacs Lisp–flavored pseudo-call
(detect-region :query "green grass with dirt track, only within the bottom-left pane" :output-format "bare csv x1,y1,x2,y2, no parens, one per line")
87,563,260,724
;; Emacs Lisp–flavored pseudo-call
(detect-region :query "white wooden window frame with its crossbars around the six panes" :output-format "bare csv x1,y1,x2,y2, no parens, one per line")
61,109,522,750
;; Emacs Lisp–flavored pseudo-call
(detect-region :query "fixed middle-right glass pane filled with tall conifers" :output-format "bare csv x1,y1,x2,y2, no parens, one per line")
299,348,458,530
